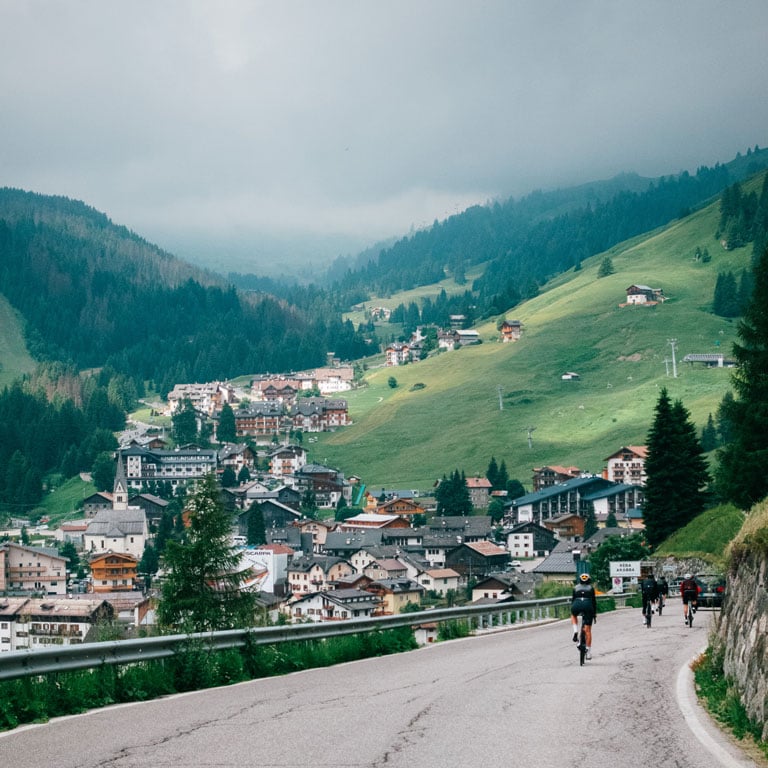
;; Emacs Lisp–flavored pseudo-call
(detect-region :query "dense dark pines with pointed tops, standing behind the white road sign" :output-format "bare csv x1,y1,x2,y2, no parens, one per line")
643,387,709,547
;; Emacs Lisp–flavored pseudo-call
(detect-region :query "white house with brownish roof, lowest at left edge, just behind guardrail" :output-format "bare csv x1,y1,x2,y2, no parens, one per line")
0,596,114,652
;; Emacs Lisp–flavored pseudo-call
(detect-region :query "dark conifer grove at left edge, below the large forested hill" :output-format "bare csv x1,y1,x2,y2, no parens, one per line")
0,371,125,515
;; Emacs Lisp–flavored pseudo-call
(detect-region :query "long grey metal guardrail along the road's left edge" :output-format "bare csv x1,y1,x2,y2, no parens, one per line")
0,597,584,680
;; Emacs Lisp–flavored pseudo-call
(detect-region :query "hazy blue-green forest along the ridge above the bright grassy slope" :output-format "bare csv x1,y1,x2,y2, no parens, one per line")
328,147,768,317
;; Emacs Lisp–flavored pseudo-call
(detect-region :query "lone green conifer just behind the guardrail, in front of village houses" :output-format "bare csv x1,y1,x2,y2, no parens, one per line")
158,473,254,632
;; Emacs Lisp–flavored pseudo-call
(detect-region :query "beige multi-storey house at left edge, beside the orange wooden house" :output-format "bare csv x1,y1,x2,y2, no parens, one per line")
0,541,67,596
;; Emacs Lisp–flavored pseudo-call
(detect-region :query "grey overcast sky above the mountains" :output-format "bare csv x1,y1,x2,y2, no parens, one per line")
0,0,768,272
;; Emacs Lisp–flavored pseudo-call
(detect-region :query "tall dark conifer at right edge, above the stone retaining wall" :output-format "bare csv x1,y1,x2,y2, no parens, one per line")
716,248,768,509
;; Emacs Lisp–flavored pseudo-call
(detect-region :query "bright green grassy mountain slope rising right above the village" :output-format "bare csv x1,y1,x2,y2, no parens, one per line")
313,177,762,489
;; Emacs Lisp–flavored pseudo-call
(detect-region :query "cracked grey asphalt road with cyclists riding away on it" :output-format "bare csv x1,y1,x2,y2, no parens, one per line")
0,602,754,768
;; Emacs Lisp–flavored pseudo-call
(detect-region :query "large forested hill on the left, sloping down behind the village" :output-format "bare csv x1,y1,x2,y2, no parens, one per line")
0,190,368,395
